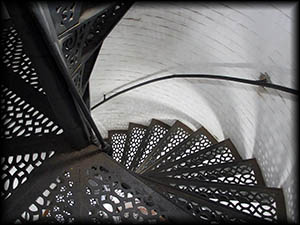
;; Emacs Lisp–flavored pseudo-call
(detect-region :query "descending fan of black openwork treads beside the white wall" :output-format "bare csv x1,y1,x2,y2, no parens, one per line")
103,119,286,223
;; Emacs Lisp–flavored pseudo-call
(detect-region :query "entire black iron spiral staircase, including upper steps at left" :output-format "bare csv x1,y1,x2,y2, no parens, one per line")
1,2,287,224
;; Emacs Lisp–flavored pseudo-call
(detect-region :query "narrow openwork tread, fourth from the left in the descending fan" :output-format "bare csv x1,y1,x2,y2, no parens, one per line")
136,120,193,173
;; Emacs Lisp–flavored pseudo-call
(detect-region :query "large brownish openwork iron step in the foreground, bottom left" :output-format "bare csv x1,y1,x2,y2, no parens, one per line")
6,148,193,223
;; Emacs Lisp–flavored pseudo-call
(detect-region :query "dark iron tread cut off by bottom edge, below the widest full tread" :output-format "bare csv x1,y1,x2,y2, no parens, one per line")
140,175,268,224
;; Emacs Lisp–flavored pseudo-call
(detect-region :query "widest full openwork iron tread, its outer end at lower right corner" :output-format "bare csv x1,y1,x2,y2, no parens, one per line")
141,175,286,222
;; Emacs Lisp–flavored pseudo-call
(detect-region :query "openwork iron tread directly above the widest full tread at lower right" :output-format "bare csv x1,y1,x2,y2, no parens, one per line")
148,159,265,186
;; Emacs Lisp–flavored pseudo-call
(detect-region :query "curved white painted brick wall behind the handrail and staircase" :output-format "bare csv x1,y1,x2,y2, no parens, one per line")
91,2,298,221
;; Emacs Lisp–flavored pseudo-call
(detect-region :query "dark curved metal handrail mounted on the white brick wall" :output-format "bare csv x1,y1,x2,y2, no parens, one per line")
91,74,298,110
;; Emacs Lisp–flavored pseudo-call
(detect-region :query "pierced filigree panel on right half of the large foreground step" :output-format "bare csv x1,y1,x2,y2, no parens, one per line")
86,165,167,223
